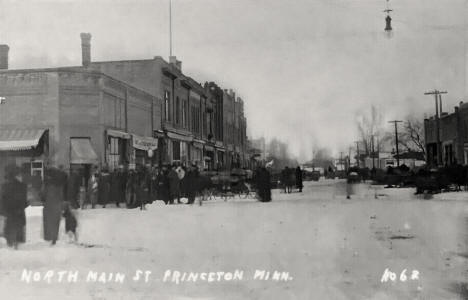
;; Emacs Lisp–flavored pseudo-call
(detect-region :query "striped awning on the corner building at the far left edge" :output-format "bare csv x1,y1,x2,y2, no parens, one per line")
0,129,46,151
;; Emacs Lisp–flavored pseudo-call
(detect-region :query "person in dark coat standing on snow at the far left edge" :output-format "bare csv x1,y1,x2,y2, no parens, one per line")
1,165,28,249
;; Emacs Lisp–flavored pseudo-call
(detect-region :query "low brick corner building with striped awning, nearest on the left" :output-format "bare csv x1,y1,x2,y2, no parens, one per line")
0,68,161,183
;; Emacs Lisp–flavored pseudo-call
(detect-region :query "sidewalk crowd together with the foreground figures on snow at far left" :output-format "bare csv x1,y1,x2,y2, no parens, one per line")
0,164,205,248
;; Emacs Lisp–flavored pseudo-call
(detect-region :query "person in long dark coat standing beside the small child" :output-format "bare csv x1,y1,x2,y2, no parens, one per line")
43,169,67,245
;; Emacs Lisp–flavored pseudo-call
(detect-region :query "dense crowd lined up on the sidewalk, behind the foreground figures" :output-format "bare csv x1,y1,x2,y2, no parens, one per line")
68,164,199,210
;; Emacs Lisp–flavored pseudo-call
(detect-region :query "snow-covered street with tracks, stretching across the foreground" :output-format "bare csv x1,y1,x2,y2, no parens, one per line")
0,180,468,299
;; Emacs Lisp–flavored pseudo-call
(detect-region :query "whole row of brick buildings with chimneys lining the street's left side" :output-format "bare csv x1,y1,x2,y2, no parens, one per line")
0,34,247,180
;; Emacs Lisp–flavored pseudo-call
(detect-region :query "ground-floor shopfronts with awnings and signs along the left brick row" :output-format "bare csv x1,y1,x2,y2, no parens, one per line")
0,123,247,185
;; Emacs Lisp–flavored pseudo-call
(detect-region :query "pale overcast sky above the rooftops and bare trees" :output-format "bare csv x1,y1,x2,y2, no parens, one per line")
0,0,468,162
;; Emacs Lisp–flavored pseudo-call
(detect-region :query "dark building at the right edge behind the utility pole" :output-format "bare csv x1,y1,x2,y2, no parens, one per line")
424,102,468,166
